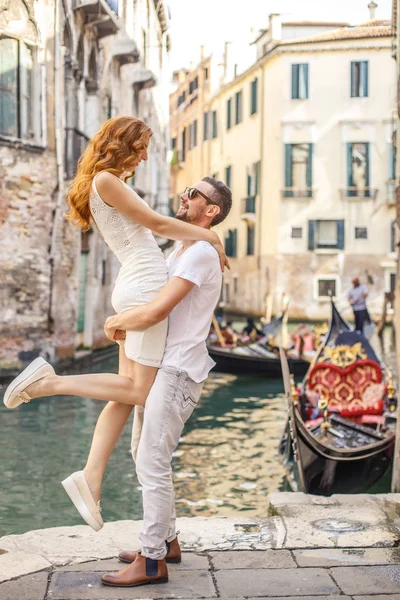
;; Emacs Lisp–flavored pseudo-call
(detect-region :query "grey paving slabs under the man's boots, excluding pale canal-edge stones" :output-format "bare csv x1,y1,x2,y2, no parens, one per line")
0,548,400,600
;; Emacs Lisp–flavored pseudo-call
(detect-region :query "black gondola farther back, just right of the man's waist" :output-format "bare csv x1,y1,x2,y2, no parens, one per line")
207,314,310,379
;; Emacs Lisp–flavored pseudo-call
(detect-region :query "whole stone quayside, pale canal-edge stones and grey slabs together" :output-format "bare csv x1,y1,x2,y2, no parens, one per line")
0,494,400,600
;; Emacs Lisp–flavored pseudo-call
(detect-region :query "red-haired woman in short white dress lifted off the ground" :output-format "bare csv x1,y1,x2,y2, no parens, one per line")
4,117,226,530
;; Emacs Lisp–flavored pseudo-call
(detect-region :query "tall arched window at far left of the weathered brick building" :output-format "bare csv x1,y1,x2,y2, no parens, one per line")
0,38,36,141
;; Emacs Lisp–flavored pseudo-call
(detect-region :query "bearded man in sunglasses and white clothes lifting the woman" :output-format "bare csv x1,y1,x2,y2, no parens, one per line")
102,177,232,587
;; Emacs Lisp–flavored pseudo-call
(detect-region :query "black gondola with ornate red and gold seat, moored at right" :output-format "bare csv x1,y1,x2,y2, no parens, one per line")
280,301,397,496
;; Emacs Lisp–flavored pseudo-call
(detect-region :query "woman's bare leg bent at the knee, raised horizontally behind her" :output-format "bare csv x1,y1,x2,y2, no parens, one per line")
26,360,157,406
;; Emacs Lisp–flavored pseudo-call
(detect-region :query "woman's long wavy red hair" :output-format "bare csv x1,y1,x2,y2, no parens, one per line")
65,117,151,231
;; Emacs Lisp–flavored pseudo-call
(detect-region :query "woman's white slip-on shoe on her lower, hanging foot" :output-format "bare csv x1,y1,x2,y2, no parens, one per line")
61,471,104,531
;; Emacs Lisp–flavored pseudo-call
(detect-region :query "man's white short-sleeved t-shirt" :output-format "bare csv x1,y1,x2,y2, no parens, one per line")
162,242,222,383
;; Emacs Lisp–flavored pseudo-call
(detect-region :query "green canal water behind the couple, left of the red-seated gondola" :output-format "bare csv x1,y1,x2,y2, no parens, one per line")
0,359,286,536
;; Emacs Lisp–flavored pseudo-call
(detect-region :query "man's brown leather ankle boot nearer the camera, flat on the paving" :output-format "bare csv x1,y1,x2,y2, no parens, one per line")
101,554,168,587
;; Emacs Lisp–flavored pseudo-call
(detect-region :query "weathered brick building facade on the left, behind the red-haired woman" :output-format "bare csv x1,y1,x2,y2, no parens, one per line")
0,0,170,370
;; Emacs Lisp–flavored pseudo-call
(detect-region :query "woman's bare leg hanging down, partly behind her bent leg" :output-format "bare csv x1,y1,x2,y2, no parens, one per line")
83,344,140,502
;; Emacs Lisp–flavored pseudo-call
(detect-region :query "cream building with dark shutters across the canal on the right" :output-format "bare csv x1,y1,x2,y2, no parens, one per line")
171,15,396,319
